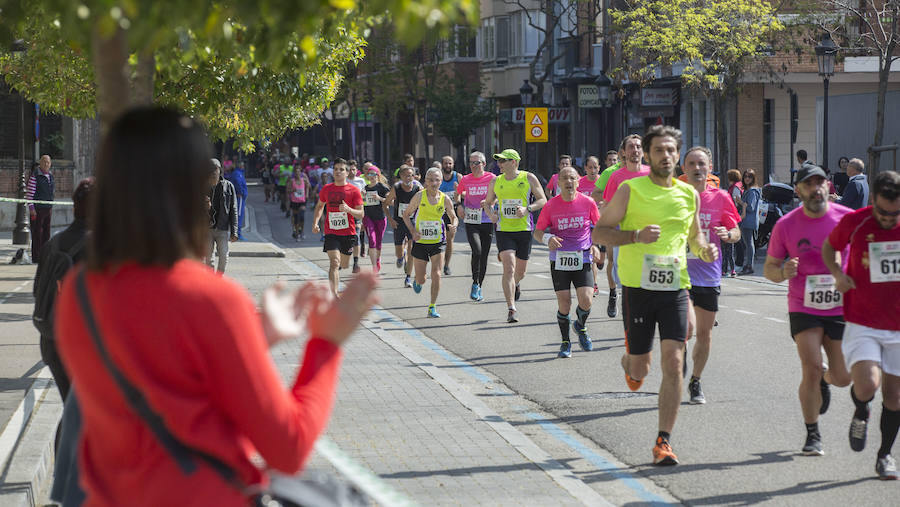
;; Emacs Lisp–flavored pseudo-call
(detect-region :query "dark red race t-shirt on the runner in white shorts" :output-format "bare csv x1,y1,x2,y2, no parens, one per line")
828,206,900,331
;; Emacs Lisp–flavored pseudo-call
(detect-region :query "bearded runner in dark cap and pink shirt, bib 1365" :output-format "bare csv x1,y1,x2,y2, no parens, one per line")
763,165,851,456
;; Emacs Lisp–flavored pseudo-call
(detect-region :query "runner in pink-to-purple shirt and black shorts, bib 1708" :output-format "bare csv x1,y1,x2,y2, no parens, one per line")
534,167,600,357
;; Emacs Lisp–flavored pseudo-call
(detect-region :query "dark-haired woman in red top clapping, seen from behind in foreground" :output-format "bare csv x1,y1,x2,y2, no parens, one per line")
57,108,375,507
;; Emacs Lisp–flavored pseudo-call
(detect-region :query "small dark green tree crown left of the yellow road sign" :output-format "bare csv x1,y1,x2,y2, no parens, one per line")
426,72,494,147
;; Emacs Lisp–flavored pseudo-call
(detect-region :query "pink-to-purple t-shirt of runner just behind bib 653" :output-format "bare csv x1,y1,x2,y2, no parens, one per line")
687,187,741,287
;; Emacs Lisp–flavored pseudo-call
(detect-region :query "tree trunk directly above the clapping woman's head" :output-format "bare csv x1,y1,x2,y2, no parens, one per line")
91,26,131,138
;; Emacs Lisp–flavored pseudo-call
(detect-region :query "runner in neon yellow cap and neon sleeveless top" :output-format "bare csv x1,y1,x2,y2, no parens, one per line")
482,149,547,322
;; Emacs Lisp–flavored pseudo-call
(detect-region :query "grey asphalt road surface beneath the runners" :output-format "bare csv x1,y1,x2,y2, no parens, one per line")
250,189,900,506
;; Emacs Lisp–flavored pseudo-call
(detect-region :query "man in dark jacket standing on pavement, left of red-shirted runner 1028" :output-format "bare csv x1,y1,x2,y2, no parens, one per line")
205,159,238,274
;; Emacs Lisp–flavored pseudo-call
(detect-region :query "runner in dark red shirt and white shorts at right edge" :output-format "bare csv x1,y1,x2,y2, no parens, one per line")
824,171,900,480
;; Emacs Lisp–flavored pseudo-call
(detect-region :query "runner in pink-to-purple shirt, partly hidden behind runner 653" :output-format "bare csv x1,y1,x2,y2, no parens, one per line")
684,146,741,405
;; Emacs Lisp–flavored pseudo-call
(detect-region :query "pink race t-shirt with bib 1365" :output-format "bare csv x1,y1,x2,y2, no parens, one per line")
766,203,853,316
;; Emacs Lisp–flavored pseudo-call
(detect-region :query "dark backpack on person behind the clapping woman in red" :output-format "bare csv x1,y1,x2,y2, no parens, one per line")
31,237,86,338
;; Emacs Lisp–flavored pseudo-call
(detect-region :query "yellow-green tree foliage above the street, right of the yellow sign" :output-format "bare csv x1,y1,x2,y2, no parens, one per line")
610,0,784,92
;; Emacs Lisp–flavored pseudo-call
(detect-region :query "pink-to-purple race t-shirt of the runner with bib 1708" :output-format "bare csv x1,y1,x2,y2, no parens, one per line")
536,193,600,263
